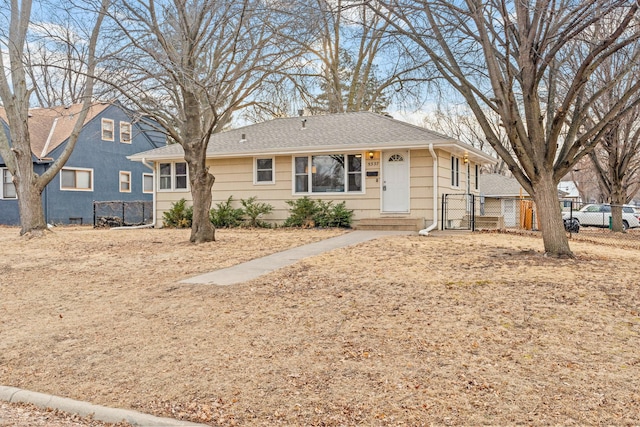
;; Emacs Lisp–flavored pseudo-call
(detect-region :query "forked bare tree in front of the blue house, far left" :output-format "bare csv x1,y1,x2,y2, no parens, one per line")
0,0,109,235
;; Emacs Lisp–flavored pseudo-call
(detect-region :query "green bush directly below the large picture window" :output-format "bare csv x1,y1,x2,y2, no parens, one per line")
283,196,353,228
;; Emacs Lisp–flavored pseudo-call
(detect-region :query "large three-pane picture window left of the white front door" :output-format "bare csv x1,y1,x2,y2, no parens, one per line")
294,154,362,193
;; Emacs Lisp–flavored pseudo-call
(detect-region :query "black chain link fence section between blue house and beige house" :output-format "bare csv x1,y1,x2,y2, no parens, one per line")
93,200,153,228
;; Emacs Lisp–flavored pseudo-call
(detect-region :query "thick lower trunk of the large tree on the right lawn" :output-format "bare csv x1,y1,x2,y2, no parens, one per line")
533,172,573,257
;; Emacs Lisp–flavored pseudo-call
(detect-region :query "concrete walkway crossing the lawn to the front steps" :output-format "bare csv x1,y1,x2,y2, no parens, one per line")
180,230,415,285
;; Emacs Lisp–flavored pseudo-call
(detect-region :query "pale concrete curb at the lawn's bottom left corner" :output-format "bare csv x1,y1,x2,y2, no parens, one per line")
0,386,206,427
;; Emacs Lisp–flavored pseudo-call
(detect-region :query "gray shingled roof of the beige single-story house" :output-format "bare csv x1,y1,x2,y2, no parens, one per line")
129,112,491,162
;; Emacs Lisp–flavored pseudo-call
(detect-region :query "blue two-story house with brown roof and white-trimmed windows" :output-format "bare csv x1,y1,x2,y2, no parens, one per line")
0,103,165,225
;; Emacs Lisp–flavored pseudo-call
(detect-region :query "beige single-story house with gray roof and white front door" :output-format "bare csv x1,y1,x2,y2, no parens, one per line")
128,112,494,230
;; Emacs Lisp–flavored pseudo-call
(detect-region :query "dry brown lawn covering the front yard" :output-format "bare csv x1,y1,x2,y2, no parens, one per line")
0,227,640,426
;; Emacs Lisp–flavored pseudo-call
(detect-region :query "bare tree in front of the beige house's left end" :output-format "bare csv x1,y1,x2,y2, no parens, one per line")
104,0,304,243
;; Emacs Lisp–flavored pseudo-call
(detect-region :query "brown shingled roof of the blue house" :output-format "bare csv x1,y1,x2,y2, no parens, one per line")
0,103,111,159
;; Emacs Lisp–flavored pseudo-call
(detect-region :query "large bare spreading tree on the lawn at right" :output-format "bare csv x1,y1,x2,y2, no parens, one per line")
376,0,640,256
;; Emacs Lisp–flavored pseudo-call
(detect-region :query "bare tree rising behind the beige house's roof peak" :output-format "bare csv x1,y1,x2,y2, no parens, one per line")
291,0,425,113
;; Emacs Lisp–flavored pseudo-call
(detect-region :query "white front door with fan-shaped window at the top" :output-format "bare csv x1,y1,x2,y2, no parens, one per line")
382,150,409,213
